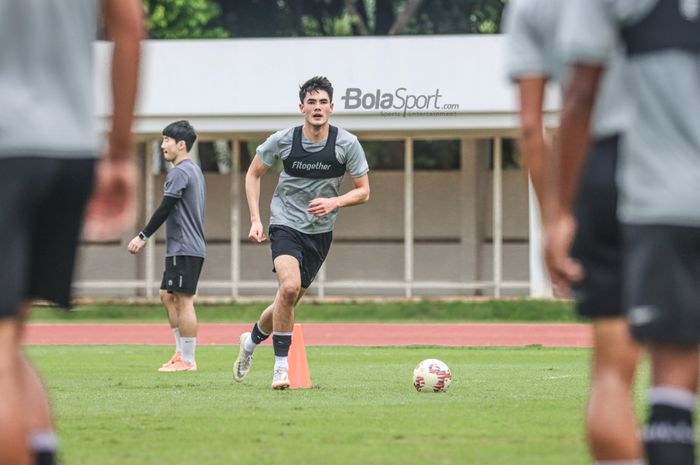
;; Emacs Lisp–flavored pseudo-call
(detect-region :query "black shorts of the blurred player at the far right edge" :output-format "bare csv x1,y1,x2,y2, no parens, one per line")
624,225,700,345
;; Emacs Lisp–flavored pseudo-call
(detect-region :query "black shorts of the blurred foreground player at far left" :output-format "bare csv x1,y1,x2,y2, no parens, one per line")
0,157,96,318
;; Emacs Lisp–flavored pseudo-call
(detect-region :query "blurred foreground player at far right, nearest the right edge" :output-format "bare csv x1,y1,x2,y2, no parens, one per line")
547,0,700,465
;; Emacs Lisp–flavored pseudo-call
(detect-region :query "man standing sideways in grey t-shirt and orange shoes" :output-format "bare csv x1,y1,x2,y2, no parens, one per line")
127,120,207,372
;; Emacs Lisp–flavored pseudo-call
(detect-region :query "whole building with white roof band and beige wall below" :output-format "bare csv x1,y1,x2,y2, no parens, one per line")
78,35,558,295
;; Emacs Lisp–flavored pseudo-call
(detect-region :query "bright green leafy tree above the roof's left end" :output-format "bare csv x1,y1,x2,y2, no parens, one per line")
144,0,229,39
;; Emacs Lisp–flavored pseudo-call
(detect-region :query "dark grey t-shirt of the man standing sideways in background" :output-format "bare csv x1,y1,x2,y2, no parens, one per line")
164,159,207,258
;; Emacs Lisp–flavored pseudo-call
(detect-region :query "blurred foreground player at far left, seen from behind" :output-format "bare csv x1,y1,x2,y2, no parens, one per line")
0,0,143,465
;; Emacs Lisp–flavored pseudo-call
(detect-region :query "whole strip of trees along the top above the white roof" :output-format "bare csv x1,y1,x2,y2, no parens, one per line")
145,0,507,39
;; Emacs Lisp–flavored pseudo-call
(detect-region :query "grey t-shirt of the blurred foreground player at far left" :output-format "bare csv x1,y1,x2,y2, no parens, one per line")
0,0,101,158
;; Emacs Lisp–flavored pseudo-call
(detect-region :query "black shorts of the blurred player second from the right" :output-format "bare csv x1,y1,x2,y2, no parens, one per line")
571,132,624,318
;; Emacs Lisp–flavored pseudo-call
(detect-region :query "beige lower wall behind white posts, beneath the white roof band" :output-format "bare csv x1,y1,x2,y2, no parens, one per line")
72,141,529,296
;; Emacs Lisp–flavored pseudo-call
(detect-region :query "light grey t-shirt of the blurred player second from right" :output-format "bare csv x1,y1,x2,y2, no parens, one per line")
506,0,632,139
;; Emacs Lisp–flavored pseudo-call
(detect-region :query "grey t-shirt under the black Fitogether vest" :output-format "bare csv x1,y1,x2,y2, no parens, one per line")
256,127,369,234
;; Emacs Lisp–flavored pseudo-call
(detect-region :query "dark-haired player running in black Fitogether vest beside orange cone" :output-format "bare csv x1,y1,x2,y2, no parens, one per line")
233,77,369,389
